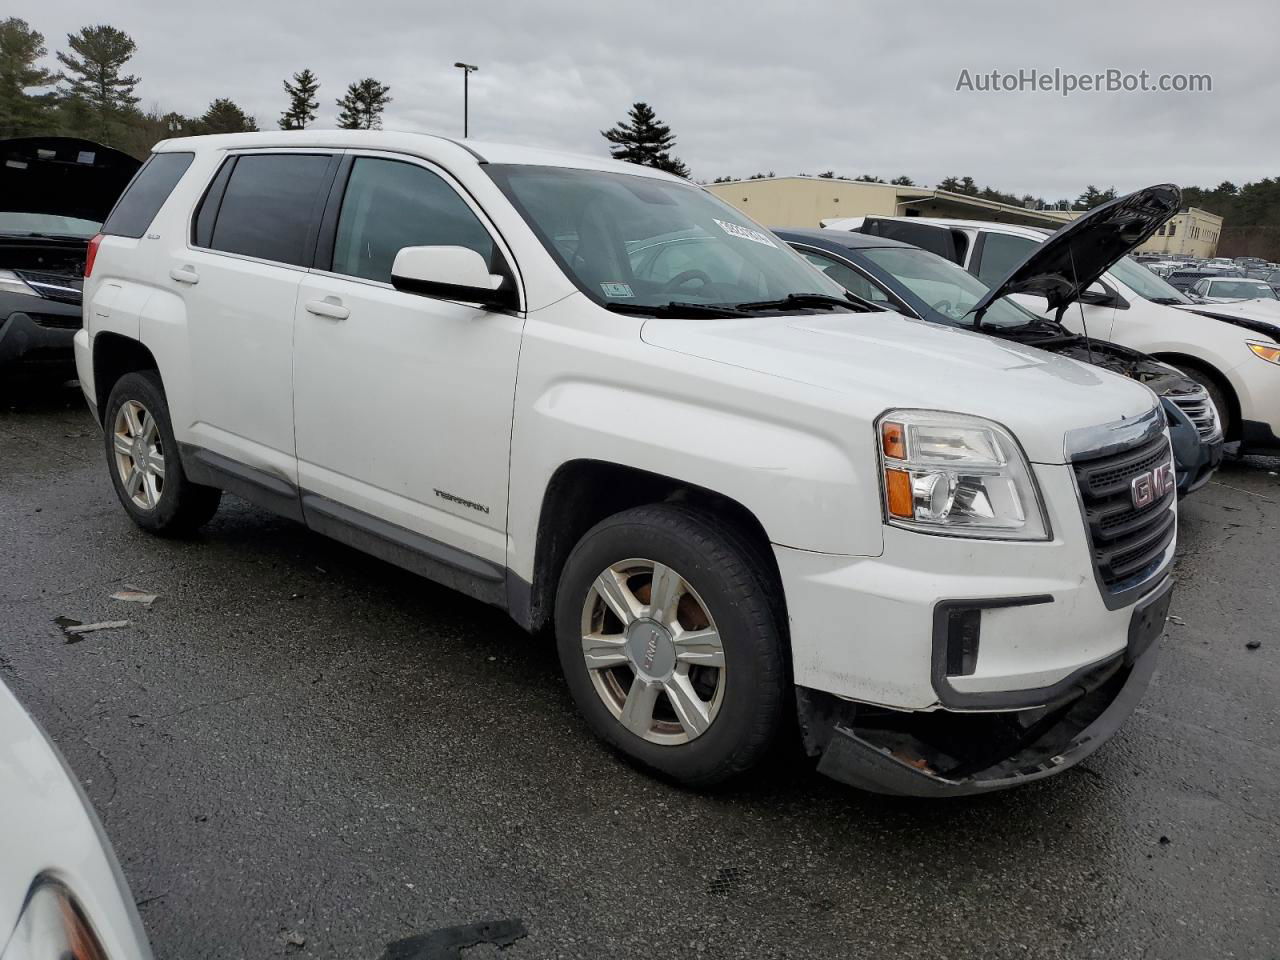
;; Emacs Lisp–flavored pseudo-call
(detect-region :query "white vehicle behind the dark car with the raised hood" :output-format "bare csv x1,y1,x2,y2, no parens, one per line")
822,216,1280,454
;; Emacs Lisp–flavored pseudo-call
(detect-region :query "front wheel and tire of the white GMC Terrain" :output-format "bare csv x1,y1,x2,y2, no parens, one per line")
556,504,790,786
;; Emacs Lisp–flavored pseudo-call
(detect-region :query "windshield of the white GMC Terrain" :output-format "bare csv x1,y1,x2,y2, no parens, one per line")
485,165,844,308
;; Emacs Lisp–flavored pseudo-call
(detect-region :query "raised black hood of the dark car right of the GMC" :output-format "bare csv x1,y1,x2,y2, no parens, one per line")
973,183,1183,317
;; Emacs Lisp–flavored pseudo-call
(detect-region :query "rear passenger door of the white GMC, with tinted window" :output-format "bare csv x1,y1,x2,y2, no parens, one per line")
180,150,338,485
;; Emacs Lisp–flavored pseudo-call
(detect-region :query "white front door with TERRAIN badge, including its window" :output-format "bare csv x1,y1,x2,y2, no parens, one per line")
293,151,524,568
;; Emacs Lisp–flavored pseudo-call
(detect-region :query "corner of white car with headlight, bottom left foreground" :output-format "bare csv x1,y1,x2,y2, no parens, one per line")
0,684,151,960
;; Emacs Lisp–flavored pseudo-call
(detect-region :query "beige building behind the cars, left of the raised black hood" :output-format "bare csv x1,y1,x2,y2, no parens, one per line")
707,177,1070,230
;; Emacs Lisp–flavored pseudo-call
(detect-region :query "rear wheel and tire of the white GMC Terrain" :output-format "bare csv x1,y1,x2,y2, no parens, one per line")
102,370,223,536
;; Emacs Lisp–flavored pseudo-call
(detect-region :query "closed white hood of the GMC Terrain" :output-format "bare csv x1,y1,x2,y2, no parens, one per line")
641,312,1157,463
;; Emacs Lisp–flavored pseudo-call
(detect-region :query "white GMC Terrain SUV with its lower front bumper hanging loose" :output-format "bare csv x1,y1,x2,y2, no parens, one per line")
76,131,1176,795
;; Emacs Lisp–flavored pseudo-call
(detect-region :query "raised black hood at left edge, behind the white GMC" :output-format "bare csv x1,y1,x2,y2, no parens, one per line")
0,137,142,221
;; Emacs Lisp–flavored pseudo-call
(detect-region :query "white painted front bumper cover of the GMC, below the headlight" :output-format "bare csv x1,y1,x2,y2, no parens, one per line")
774,465,1172,710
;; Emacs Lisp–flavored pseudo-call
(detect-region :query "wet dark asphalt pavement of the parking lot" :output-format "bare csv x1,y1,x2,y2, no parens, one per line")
0,378,1280,960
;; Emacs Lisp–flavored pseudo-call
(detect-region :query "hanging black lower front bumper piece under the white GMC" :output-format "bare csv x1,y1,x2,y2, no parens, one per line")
797,582,1171,797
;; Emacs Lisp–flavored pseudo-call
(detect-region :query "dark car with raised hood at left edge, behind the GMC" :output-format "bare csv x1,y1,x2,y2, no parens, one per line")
0,137,141,371
